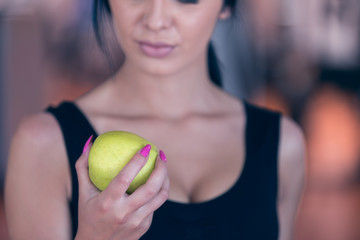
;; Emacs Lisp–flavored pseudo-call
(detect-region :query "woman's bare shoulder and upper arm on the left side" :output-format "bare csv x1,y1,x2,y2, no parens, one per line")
5,113,70,239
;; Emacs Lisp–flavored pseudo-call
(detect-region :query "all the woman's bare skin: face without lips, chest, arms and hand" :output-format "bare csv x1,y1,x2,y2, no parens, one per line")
5,0,305,240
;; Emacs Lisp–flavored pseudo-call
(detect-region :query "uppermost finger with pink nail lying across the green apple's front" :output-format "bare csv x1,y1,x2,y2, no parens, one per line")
104,144,151,199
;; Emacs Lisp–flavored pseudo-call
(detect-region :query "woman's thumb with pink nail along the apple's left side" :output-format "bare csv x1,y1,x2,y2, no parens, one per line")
75,135,99,201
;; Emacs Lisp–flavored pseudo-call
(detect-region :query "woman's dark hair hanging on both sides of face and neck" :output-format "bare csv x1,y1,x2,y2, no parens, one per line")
93,0,238,87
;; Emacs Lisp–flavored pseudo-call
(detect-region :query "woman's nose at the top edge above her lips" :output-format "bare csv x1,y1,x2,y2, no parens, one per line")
143,0,171,31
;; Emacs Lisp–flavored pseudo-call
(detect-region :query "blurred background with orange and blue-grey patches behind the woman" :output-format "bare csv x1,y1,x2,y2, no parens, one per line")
0,0,360,240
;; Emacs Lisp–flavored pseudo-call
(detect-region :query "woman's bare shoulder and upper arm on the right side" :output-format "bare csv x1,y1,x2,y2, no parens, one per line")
278,117,306,240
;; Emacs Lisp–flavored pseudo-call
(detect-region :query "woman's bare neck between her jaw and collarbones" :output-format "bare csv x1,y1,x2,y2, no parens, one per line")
111,57,222,118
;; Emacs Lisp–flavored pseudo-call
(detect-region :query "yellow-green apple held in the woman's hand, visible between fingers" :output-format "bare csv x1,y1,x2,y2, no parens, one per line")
89,131,159,194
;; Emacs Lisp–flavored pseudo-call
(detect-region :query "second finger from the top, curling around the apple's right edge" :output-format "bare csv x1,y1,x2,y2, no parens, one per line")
128,157,168,210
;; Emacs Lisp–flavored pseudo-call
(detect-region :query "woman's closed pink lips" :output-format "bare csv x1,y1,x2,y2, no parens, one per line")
139,41,175,58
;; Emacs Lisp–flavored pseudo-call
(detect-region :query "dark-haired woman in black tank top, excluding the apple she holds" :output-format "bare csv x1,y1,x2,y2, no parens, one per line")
6,0,304,240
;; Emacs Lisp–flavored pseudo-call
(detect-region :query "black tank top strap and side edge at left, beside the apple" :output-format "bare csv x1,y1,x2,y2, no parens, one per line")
46,102,97,237
